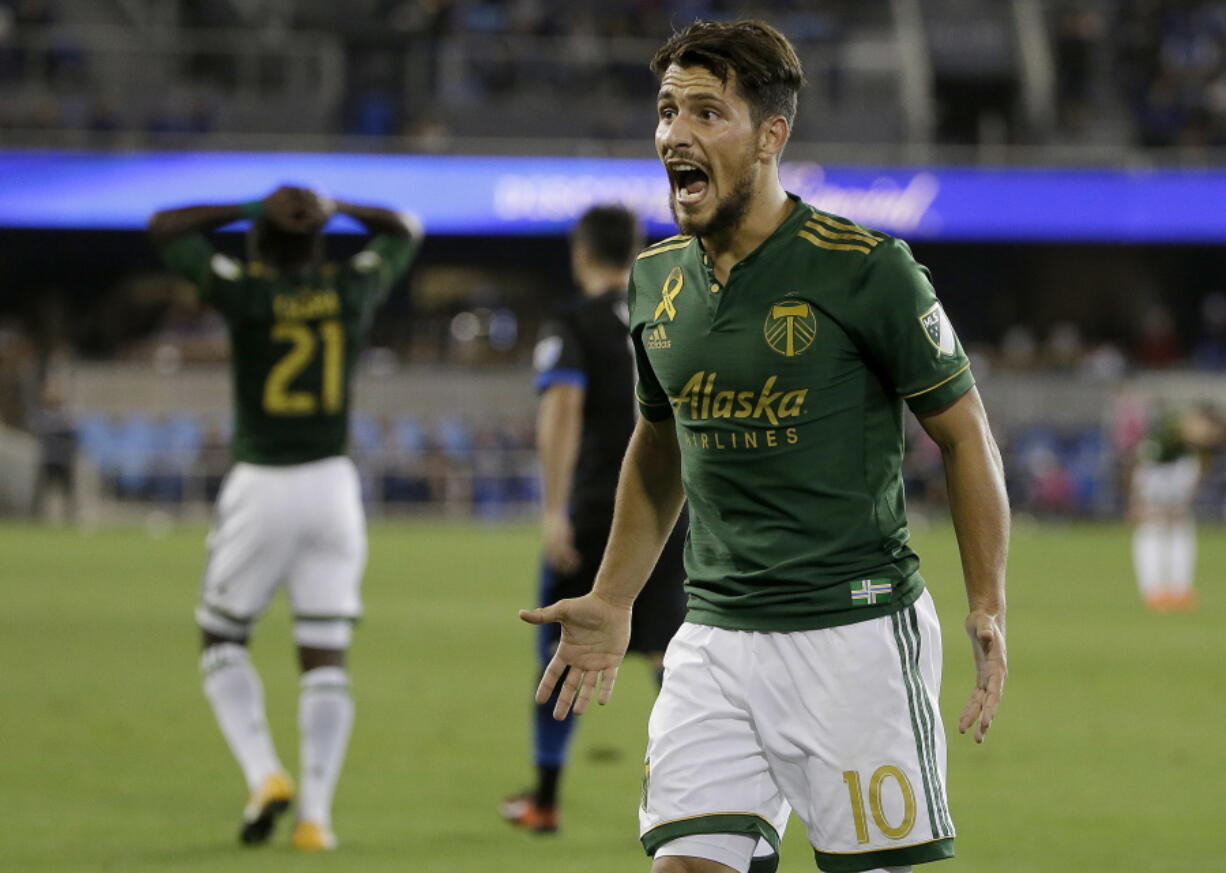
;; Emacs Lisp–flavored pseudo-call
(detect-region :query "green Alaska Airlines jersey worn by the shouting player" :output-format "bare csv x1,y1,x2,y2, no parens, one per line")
630,200,975,631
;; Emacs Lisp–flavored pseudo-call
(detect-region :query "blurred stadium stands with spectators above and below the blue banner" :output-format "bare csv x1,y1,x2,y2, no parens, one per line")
0,0,1226,517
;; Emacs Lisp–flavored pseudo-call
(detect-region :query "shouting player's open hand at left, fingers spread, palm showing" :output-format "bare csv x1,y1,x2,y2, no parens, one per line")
520,593,630,721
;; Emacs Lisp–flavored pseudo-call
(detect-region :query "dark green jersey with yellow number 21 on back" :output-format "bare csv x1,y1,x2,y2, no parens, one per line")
162,234,417,465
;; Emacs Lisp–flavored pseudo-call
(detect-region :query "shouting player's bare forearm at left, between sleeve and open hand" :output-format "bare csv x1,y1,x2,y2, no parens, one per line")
592,419,685,606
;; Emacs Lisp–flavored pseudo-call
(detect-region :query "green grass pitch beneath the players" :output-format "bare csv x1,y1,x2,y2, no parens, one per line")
0,521,1226,873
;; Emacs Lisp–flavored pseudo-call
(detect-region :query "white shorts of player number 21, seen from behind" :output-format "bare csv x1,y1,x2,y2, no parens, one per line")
196,457,367,649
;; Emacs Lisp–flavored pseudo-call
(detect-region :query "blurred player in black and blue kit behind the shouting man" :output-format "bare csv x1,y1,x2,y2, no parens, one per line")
503,206,685,834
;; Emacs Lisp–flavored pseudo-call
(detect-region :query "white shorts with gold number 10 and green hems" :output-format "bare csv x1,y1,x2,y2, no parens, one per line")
639,591,954,873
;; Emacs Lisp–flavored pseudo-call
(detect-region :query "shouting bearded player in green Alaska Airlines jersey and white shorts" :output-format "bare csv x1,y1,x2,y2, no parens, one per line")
521,21,1009,873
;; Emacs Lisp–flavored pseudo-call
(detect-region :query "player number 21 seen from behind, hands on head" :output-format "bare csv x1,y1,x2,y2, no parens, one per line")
150,186,422,851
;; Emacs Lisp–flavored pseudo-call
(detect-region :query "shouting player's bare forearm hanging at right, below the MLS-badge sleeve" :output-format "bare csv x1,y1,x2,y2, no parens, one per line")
942,421,1009,623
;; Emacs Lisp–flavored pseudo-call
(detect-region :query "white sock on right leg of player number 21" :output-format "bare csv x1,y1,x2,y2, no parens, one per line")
298,667,353,826
